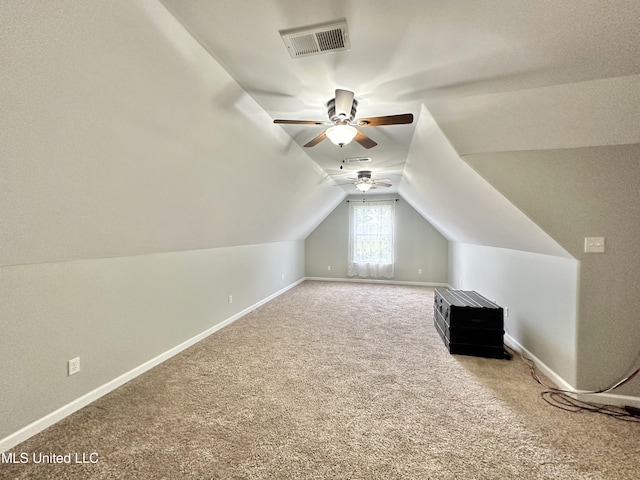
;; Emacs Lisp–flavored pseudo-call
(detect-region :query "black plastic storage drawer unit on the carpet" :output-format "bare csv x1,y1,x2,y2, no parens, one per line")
433,288,510,358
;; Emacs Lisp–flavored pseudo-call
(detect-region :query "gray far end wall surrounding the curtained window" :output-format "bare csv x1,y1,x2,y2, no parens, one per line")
305,195,448,284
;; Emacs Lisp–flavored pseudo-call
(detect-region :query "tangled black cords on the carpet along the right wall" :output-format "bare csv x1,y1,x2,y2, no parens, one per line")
505,345,640,423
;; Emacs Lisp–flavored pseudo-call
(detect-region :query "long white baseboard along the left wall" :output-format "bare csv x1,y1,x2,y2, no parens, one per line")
0,278,305,453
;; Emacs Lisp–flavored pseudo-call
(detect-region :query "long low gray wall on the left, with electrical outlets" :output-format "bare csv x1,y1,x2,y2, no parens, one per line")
0,241,304,444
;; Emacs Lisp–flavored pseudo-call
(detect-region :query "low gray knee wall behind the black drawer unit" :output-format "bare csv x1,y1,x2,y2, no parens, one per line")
449,243,579,388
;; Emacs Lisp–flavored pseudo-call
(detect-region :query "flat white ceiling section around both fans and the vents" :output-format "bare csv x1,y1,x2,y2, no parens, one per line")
162,0,640,193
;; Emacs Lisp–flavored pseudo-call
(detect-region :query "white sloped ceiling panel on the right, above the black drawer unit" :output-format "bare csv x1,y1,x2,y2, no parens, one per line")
400,107,571,257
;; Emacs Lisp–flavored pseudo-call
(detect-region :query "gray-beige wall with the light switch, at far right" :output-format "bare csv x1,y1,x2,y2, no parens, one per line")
467,144,640,396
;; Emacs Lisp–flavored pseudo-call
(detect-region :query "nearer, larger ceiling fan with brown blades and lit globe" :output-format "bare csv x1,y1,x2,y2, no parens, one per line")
273,88,413,148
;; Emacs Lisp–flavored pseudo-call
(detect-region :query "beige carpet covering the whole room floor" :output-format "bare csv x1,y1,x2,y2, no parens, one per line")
0,282,640,480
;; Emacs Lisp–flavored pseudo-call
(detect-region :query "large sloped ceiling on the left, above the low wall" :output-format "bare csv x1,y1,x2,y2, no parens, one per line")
0,1,345,265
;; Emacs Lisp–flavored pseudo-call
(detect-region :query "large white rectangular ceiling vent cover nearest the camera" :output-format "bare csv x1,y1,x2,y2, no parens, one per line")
279,19,351,58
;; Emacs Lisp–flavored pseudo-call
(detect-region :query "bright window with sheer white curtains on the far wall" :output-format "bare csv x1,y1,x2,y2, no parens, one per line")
347,200,395,278
